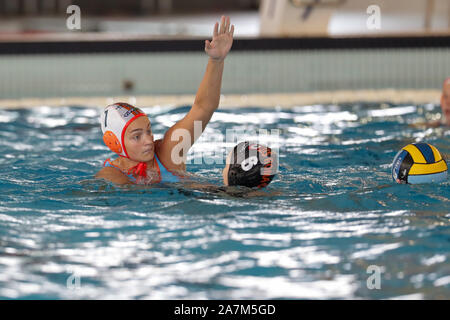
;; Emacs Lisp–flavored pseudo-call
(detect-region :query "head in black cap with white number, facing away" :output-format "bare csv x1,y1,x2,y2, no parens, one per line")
222,141,278,188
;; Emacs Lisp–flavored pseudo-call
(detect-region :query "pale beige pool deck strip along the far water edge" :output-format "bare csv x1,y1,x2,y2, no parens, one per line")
0,89,441,109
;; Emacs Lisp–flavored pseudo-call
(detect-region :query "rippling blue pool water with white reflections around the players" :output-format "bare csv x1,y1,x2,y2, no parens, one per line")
0,103,450,299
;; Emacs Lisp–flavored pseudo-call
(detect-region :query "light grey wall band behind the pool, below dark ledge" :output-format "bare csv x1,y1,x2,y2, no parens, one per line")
0,48,450,99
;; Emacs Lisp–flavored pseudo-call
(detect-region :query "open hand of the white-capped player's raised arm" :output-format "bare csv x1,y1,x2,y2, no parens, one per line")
205,16,234,60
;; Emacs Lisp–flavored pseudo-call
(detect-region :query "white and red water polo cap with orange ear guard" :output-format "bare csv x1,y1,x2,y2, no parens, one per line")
100,102,146,158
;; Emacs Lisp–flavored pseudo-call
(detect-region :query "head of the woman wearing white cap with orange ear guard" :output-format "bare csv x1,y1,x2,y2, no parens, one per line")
100,102,154,162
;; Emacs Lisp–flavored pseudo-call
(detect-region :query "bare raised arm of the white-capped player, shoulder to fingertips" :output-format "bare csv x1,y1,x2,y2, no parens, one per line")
157,16,234,168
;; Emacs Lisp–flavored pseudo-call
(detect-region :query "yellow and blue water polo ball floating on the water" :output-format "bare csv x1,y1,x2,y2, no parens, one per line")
392,142,448,184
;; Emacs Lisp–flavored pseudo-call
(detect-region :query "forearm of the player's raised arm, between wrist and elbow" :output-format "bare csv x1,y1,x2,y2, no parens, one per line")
194,58,224,121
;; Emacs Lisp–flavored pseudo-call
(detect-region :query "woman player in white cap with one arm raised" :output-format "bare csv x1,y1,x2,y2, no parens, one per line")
96,16,234,184
